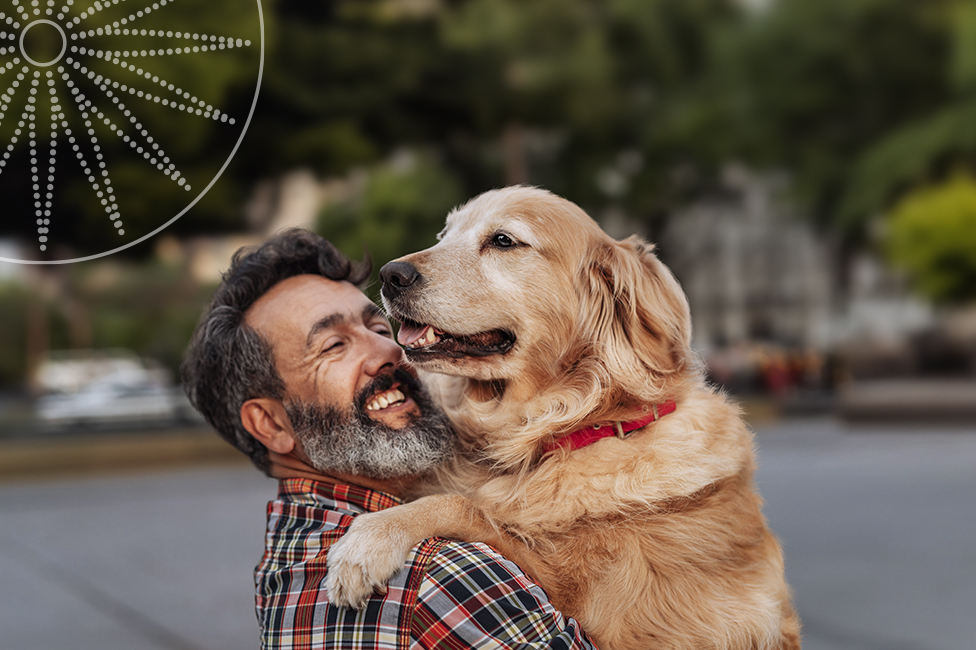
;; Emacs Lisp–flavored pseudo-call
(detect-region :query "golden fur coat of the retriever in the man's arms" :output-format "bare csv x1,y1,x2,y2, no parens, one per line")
329,187,800,650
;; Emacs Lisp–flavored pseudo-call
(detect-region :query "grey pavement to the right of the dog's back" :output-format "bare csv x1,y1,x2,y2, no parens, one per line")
757,421,976,650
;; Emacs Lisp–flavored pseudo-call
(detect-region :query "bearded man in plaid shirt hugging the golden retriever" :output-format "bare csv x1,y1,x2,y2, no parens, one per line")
184,230,592,650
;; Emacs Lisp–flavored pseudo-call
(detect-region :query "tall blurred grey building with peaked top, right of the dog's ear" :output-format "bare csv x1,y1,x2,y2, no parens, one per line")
661,167,836,349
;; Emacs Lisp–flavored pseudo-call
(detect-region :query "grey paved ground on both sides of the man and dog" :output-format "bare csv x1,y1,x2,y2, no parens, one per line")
0,420,976,650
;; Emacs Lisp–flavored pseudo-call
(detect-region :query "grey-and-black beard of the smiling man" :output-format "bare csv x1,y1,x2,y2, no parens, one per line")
285,384,456,479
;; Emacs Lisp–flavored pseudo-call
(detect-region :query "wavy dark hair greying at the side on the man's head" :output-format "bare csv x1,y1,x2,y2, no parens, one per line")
182,228,372,474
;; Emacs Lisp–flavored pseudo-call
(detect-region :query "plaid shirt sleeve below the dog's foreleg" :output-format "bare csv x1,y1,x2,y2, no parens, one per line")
411,540,596,650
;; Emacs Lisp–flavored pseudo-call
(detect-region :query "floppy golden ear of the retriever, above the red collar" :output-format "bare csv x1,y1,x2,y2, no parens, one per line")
579,235,692,394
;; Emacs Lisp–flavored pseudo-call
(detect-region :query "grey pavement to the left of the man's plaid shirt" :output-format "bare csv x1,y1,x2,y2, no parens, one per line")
0,466,275,650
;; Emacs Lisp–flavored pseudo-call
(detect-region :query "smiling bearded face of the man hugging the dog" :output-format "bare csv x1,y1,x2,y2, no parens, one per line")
245,275,453,478
